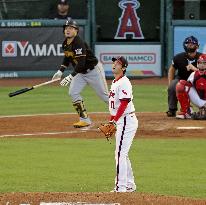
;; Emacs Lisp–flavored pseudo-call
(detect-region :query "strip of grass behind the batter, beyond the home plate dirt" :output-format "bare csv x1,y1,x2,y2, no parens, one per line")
0,85,167,115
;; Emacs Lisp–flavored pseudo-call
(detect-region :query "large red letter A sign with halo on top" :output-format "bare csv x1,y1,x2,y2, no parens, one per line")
114,0,144,39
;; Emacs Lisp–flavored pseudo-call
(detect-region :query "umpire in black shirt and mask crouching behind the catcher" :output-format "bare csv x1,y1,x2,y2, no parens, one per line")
166,36,201,117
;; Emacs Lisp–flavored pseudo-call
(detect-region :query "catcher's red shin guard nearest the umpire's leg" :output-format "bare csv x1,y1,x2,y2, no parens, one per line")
176,80,191,113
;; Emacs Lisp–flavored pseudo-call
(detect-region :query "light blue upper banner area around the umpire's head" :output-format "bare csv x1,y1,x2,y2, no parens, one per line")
174,26,206,55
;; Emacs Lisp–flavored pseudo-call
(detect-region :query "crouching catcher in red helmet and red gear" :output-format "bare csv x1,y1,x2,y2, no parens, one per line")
176,54,206,120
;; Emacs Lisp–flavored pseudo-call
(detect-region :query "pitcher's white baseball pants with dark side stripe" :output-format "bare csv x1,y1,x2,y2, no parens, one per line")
115,113,138,192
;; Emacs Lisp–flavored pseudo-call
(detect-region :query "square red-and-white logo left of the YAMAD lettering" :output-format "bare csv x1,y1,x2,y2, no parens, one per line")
2,41,17,57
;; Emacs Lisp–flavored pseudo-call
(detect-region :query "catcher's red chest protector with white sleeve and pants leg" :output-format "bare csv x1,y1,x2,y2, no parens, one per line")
187,71,206,108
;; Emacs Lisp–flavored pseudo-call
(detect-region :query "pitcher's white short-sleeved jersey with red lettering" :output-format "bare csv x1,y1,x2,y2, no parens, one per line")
109,76,135,116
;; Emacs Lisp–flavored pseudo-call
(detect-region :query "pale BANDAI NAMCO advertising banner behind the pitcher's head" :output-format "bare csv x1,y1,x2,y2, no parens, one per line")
95,44,161,77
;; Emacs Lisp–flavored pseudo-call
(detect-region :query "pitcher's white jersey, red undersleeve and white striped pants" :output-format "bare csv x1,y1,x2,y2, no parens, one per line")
109,76,138,192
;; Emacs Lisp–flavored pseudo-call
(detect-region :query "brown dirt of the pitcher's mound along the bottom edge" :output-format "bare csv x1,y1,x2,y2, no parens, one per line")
0,192,206,205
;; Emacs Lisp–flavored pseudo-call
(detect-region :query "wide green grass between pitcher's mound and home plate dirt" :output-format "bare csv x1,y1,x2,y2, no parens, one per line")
0,139,206,198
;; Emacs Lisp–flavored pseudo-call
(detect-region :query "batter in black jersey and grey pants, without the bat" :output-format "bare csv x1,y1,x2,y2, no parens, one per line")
52,19,109,128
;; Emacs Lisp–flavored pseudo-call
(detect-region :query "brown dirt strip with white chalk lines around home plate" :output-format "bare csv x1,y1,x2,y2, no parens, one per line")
0,113,206,138
